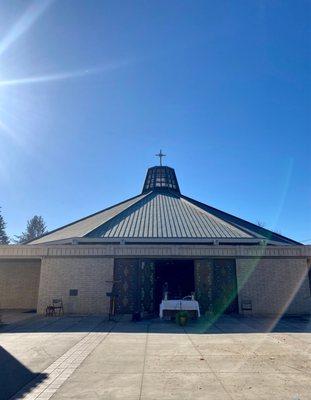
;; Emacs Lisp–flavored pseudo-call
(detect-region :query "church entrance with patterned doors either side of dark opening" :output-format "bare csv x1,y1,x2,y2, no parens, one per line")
114,258,238,315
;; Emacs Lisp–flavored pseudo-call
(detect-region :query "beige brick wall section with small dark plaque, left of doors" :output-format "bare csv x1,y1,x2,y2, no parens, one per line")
38,257,113,314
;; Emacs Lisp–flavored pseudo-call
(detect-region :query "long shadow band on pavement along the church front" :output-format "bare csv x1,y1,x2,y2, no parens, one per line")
0,314,311,335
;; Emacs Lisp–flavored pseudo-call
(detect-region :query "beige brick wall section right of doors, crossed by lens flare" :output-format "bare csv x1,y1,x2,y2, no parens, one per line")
236,258,311,314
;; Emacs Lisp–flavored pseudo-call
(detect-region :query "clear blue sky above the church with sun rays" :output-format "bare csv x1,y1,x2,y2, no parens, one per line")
0,0,311,243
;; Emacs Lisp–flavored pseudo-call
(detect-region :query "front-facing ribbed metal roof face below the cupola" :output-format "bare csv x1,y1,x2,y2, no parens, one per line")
86,192,254,239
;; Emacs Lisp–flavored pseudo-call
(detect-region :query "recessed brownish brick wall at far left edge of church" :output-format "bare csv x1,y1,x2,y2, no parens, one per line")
0,260,41,309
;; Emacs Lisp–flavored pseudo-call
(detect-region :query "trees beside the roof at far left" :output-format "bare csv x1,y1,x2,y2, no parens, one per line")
0,207,48,245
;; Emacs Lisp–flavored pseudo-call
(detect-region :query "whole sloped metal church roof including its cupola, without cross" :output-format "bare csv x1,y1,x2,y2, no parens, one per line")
29,166,300,244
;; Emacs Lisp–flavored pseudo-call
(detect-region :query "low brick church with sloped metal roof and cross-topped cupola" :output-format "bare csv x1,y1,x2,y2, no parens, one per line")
0,158,311,316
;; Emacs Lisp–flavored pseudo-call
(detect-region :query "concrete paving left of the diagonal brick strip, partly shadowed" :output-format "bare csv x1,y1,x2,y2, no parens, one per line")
0,317,107,400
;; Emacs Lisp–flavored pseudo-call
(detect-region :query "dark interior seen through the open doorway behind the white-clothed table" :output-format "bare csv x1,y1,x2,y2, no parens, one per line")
155,260,195,310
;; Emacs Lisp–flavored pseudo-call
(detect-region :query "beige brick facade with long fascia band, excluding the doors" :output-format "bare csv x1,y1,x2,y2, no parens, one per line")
0,245,311,314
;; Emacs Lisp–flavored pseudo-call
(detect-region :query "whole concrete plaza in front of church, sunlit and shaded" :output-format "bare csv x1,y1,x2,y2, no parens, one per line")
0,316,311,400
